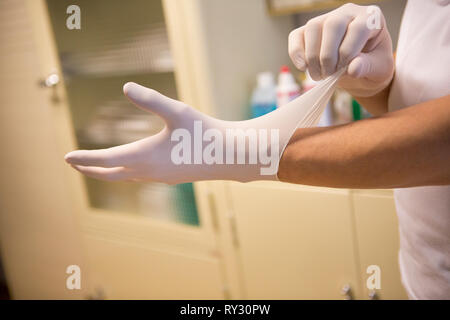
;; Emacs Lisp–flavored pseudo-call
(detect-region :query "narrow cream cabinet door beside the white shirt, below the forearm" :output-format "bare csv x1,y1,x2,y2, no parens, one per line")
353,190,407,299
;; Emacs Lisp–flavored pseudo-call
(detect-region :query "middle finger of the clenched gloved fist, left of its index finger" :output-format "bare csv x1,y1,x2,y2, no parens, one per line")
320,14,353,78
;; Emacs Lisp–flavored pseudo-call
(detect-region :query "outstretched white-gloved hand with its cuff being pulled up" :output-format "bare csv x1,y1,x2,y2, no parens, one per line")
65,74,340,184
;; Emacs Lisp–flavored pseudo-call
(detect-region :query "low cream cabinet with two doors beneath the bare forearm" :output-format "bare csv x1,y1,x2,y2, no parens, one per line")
216,182,407,299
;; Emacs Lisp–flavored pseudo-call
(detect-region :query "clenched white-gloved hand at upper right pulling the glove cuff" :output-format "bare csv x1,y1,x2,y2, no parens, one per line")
289,3,394,97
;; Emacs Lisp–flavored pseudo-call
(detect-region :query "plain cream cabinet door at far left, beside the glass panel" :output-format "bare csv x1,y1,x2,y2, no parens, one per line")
0,0,86,299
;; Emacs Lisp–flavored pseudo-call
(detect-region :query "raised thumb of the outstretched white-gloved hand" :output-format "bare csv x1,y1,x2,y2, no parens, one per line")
123,82,185,122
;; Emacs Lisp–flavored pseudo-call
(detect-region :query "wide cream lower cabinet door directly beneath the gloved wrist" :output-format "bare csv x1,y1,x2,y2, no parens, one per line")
228,182,358,299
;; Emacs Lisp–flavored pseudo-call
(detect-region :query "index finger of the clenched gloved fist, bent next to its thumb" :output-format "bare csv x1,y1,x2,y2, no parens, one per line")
338,16,377,69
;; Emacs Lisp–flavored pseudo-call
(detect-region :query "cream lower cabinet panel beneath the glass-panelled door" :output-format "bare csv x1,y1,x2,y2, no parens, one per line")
83,236,224,299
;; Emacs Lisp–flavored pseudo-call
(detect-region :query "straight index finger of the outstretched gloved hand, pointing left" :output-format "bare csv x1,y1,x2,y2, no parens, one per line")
64,143,139,168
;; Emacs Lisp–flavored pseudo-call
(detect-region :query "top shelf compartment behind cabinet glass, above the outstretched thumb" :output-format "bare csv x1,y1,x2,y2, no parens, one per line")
47,0,174,78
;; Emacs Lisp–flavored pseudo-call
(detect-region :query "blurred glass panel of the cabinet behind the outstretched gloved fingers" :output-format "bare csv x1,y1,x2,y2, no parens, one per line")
47,0,199,225
